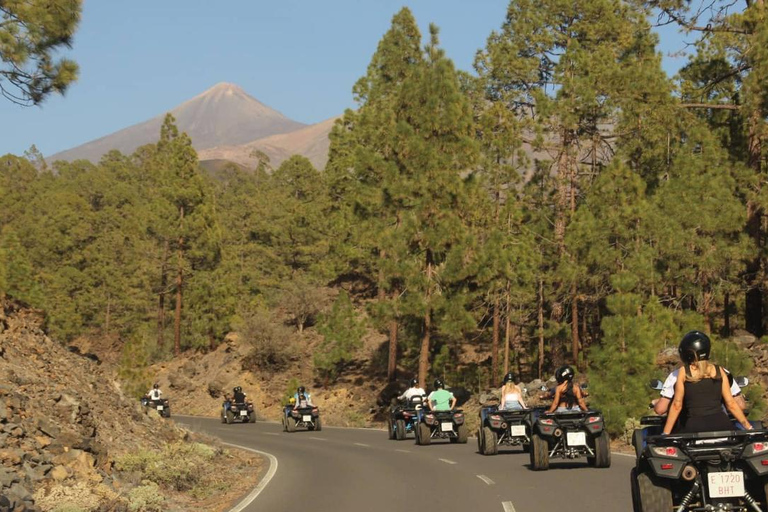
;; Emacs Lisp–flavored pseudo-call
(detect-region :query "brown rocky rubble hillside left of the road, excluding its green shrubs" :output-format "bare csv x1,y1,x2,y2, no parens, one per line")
0,301,256,511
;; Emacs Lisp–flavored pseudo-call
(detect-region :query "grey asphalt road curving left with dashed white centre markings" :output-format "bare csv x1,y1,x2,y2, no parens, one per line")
176,417,634,512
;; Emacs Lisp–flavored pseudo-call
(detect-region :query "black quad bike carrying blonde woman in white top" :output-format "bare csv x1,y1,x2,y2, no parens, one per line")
477,405,533,455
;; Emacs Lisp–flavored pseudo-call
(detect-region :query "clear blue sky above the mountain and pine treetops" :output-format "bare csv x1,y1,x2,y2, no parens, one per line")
0,0,684,155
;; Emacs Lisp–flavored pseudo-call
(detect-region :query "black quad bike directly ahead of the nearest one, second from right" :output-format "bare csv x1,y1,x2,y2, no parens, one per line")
530,410,611,471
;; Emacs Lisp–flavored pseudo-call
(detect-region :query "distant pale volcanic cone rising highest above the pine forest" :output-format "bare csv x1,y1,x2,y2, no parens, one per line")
49,83,306,162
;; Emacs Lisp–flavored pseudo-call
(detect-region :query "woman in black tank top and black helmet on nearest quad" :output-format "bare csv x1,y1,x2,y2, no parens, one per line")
664,331,752,434
